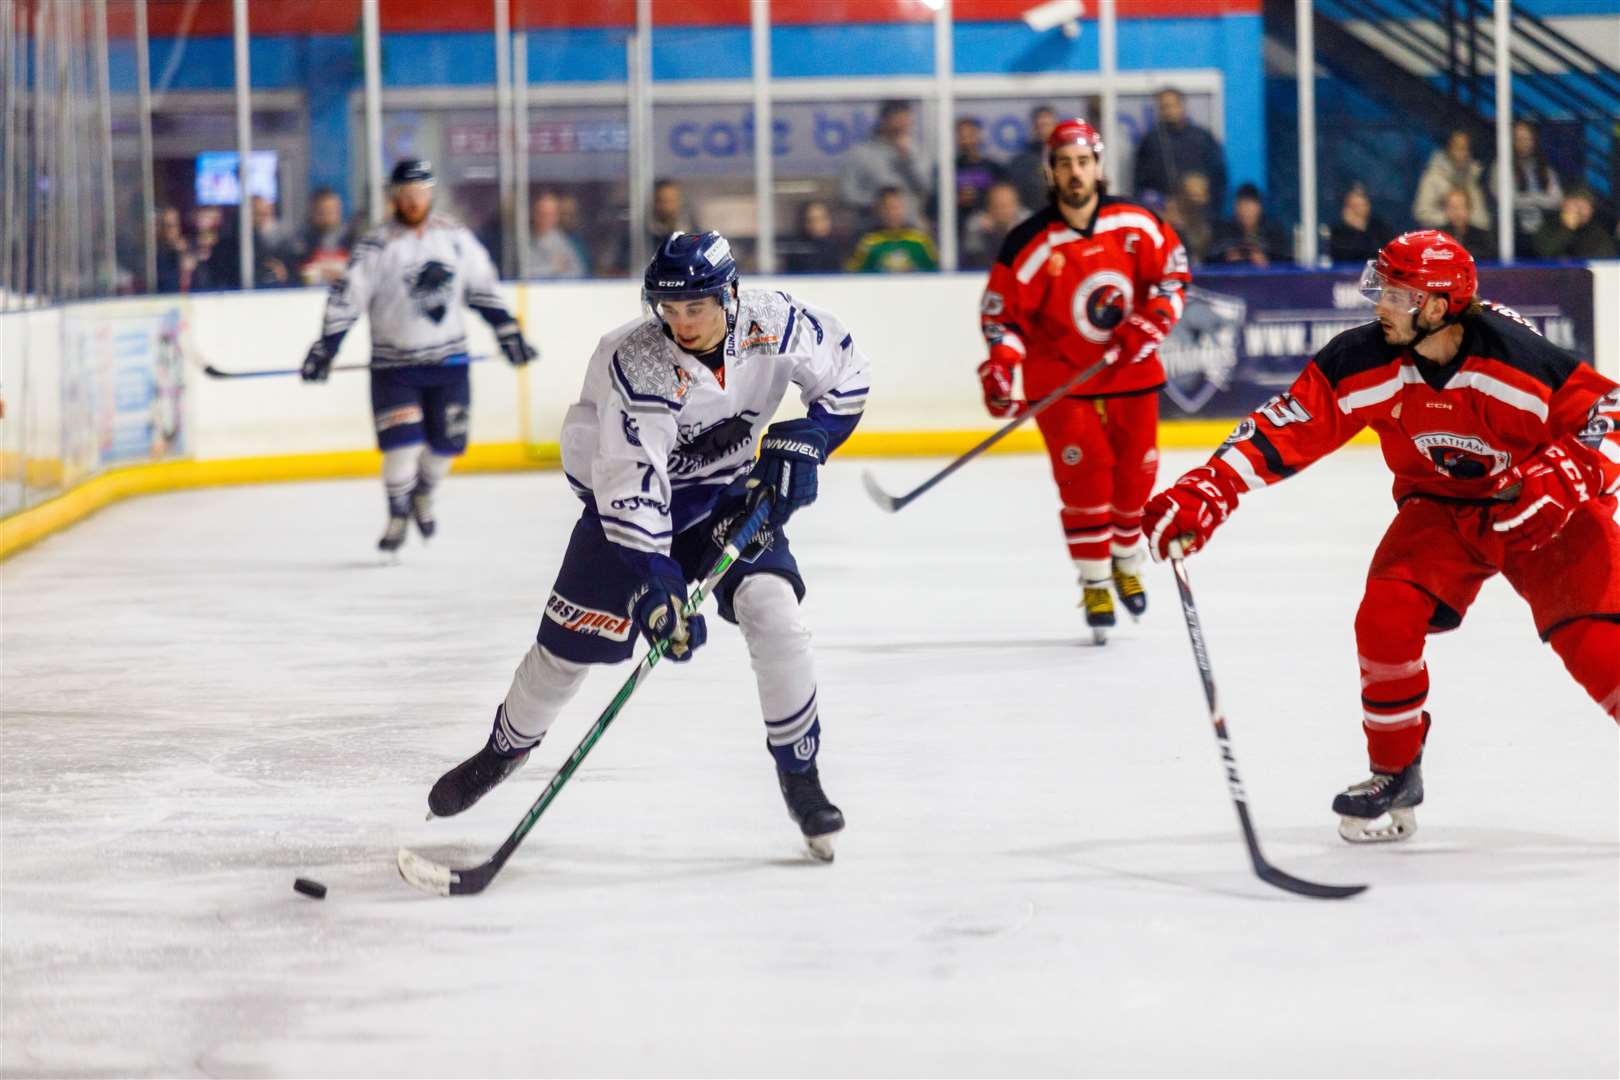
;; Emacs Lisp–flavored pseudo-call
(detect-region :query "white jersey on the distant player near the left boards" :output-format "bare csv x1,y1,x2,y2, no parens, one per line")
321,214,512,364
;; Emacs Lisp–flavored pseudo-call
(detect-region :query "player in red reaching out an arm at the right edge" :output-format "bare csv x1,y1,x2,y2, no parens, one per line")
1144,230,1620,842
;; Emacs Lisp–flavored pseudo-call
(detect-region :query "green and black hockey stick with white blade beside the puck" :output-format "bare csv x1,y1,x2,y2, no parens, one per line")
395,499,771,897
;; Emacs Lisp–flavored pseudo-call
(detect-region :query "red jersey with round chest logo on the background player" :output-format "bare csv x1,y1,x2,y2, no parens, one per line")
978,198,1191,400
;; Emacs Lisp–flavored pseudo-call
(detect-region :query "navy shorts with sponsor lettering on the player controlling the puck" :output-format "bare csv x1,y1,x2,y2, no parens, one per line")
536,507,805,664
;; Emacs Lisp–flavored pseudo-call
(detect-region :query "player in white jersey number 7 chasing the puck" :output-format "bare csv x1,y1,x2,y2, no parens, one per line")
428,232,867,858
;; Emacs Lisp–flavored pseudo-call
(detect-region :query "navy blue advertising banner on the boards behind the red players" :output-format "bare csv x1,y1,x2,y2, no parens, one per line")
1160,267,1594,419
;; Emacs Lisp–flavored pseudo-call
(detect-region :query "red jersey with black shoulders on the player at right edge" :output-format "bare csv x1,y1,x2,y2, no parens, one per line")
1212,308,1620,500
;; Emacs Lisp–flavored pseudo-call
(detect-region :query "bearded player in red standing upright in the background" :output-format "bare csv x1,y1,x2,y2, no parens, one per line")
978,120,1189,644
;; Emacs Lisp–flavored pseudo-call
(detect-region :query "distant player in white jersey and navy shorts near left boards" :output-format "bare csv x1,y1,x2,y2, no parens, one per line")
303,159,535,554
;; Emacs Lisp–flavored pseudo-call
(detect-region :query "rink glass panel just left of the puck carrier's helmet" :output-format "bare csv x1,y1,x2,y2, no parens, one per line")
512,0,633,279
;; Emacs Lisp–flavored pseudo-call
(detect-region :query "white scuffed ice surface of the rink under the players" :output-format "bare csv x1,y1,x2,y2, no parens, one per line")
0,449,1620,1077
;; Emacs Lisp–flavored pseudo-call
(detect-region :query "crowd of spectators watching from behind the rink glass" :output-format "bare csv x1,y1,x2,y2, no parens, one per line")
145,87,1620,291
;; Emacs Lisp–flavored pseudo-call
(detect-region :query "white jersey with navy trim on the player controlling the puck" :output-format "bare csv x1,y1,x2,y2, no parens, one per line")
562,288,868,554
